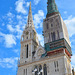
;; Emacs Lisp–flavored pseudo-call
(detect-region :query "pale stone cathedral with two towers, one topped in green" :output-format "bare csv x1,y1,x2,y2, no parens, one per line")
17,0,72,75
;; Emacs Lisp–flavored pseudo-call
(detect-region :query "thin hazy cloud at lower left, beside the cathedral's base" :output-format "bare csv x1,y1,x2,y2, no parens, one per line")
0,57,18,69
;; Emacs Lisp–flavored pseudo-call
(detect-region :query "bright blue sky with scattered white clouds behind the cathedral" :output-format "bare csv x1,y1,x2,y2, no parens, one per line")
0,0,75,75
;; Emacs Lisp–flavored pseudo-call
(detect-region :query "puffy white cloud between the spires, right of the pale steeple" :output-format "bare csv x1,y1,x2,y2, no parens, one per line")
34,10,44,28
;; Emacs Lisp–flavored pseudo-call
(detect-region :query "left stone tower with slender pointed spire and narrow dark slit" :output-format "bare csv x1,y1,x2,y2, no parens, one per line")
20,3,38,63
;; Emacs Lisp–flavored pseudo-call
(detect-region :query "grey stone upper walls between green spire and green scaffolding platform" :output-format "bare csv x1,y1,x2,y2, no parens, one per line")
43,14,70,45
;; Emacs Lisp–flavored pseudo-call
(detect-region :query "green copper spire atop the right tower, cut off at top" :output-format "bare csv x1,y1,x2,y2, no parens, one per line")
46,0,59,17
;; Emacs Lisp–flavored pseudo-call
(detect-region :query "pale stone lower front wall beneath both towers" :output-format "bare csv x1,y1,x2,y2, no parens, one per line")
18,49,71,75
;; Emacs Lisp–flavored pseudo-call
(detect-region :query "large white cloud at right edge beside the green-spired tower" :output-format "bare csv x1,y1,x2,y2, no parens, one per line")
64,15,75,37
